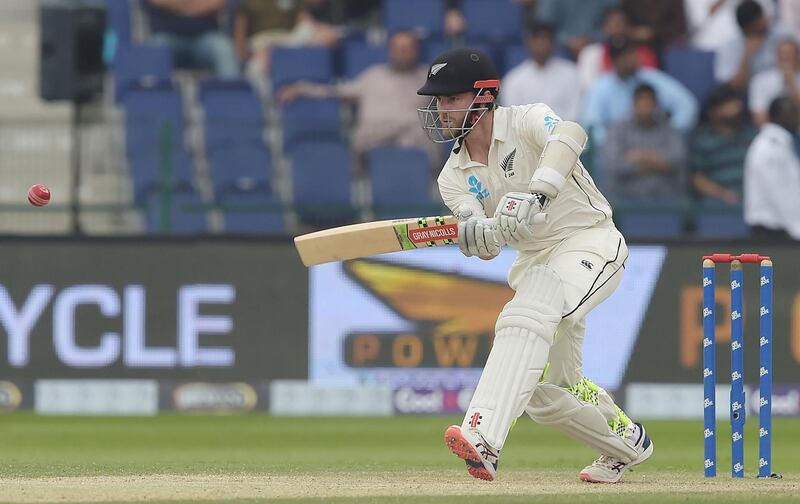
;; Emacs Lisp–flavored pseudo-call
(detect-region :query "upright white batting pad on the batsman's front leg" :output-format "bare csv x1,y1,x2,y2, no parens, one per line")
462,265,564,450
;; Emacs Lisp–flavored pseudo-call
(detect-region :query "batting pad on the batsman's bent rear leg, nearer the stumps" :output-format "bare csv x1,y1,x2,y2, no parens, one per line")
526,382,637,463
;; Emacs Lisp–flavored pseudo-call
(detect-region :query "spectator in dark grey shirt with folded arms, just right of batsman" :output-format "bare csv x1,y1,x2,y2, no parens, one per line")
603,84,686,201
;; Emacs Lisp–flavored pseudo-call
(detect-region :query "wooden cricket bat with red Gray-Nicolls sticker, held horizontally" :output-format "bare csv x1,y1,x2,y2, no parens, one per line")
294,215,458,266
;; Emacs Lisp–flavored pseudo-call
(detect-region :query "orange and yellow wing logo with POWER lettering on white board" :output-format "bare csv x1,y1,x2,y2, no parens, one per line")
343,259,514,368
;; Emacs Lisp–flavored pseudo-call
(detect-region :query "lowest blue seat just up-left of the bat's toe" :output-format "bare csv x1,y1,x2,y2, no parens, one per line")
217,184,286,234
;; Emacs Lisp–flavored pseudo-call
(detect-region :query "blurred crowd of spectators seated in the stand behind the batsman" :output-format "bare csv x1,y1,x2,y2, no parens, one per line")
130,0,800,239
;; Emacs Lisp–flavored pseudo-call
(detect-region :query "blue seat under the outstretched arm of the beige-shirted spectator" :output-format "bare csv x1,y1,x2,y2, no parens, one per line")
281,98,343,149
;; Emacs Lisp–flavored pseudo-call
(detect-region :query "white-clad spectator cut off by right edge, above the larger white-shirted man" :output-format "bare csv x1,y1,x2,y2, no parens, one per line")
749,38,800,126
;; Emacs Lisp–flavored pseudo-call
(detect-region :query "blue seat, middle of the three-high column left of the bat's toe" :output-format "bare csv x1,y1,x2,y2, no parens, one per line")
208,144,272,191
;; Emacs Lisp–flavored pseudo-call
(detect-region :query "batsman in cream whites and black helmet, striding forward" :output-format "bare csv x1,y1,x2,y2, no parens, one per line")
418,48,653,483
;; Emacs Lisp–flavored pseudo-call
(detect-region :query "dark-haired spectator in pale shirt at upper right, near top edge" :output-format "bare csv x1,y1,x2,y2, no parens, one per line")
714,0,786,91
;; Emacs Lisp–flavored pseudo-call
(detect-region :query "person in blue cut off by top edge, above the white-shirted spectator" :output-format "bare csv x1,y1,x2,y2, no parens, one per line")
536,0,619,58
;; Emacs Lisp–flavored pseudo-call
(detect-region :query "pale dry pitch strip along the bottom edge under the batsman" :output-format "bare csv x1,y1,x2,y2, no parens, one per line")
0,470,800,503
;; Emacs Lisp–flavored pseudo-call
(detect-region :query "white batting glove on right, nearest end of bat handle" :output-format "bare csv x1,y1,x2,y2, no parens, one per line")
494,192,548,243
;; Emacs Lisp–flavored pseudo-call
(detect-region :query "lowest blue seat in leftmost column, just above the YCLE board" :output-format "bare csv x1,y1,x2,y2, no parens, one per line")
145,184,208,235
